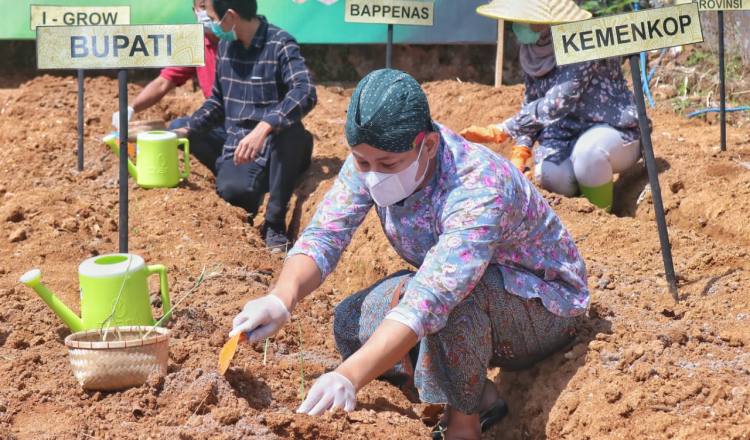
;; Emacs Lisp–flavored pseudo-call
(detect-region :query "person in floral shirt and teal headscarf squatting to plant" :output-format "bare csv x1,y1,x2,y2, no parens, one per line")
230,70,589,439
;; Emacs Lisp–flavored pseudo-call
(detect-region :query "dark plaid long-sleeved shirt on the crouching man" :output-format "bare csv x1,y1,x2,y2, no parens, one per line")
187,15,318,165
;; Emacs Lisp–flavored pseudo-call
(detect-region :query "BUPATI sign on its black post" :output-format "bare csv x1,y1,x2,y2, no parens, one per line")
36,24,204,253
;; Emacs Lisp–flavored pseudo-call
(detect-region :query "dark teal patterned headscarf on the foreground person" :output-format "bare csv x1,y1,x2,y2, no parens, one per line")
345,69,434,153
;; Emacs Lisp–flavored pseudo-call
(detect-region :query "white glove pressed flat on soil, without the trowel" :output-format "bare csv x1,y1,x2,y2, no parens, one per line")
297,371,357,416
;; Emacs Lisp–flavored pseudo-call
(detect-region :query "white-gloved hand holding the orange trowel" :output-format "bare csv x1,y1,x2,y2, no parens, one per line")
229,295,291,342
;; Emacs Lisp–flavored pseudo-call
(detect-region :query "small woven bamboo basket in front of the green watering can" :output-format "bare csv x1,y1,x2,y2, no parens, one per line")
65,326,169,391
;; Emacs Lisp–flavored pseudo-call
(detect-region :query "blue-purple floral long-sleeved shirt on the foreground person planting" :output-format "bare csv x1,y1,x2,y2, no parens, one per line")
289,125,589,339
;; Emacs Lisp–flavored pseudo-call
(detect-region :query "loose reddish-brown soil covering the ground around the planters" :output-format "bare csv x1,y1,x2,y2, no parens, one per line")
0,70,750,440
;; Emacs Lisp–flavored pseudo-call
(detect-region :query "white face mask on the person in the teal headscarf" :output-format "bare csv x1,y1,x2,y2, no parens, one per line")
362,135,429,208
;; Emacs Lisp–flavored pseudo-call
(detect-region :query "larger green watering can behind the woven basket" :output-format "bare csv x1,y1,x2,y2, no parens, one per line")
21,254,172,333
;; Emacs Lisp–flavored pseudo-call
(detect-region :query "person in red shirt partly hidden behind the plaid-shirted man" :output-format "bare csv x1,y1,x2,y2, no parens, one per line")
112,0,227,175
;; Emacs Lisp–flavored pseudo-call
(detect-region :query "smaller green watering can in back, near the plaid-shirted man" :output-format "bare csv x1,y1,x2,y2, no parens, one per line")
103,131,190,188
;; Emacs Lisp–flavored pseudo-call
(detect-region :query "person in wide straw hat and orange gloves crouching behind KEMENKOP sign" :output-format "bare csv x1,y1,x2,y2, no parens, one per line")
460,0,641,211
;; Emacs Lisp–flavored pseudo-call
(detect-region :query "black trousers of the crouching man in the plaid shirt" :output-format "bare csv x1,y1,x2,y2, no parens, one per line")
216,122,313,225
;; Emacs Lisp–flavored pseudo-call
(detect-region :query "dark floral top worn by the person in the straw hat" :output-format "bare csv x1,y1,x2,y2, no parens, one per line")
505,58,641,165
